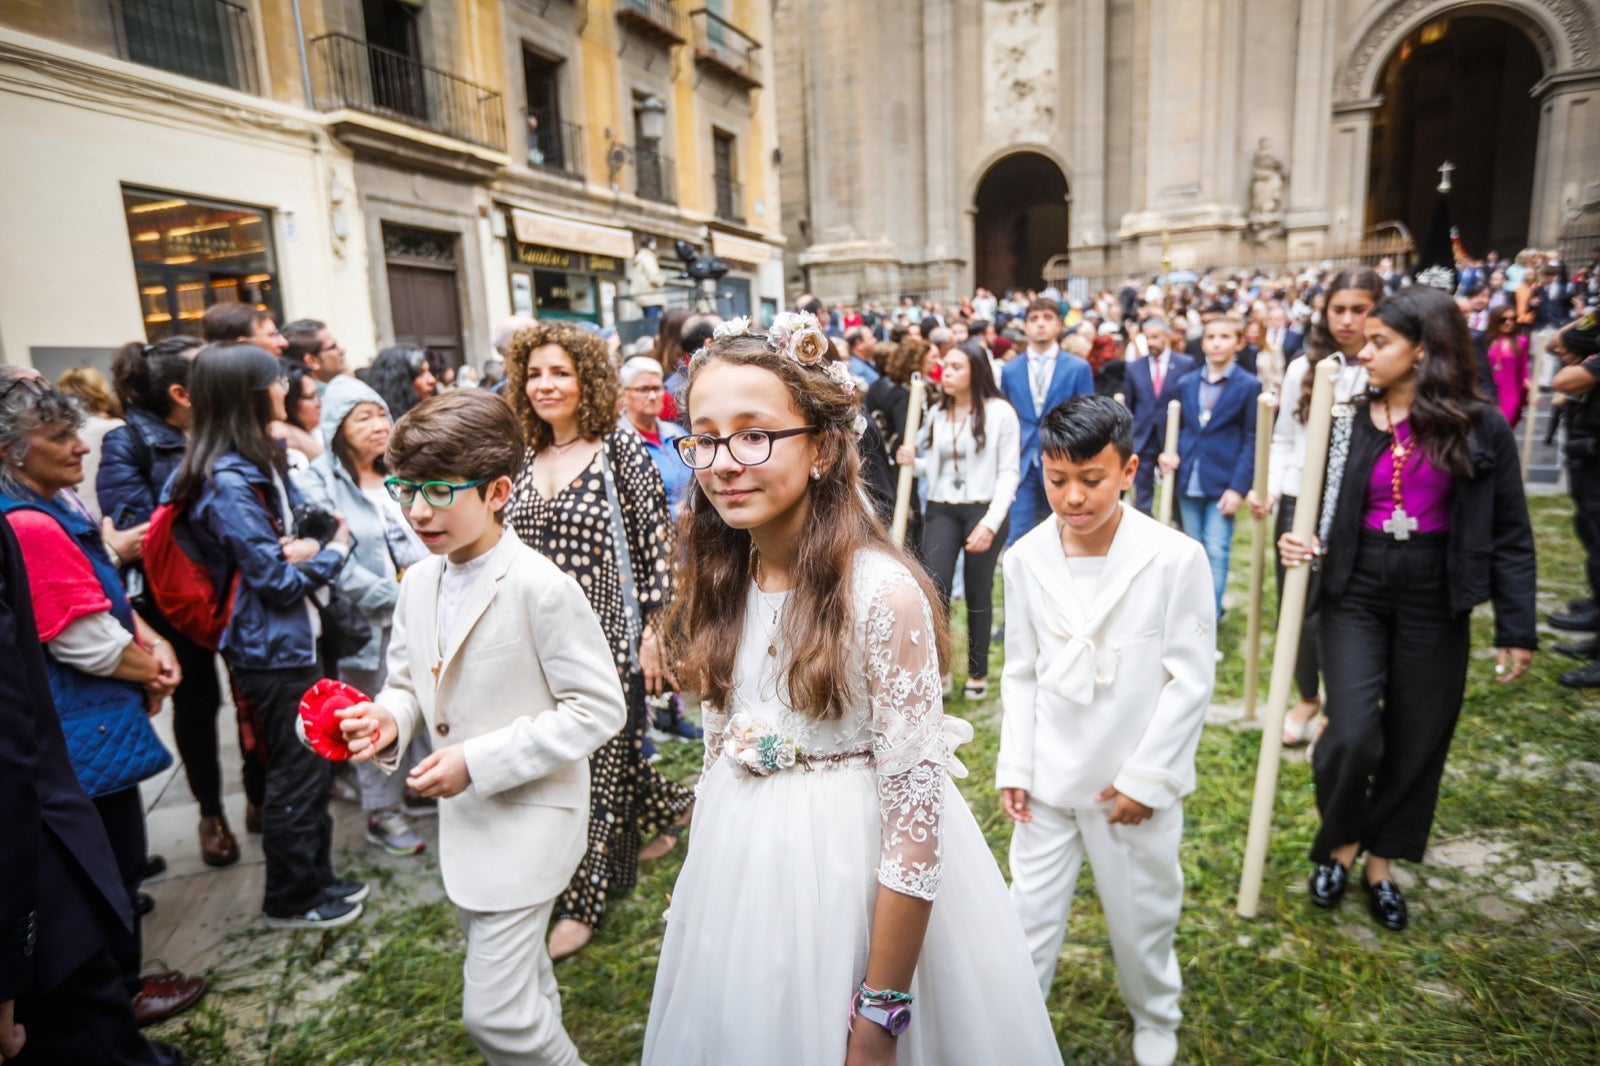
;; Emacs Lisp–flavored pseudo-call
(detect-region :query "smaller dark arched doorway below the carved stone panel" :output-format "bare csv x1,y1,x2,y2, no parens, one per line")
973,152,1067,293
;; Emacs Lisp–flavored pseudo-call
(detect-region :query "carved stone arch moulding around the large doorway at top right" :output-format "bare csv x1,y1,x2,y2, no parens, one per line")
1333,0,1600,102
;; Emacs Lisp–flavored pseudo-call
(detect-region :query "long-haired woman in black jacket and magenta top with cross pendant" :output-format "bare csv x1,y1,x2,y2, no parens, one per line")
1278,287,1536,930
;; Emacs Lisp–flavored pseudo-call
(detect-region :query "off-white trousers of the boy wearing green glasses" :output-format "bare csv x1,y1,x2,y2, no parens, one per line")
456,900,579,1066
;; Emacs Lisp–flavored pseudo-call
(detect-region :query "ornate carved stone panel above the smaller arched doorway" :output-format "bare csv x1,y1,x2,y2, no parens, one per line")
981,0,1061,141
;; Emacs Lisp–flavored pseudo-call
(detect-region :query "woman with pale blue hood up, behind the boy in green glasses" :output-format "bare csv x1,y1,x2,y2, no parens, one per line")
294,376,432,855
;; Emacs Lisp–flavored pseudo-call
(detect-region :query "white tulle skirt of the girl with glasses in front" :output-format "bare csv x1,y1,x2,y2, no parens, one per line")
643,759,1061,1066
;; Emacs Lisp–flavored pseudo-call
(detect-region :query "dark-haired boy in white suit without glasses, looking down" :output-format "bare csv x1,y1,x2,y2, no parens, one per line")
995,395,1216,1066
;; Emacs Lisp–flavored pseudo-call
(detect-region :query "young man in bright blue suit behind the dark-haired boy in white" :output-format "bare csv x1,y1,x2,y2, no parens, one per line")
1000,299,1094,544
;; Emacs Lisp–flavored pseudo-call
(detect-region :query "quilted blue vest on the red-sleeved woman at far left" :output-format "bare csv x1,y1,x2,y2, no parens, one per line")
0,490,173,797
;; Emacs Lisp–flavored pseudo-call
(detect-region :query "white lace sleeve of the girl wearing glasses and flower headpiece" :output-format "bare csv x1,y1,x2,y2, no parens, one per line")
866,570,947,900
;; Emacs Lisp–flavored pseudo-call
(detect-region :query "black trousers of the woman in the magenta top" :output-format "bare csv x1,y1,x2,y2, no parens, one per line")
1310,530,1470,863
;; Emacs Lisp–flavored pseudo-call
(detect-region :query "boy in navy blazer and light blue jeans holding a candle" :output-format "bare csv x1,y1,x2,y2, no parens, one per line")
1160,315,1261,618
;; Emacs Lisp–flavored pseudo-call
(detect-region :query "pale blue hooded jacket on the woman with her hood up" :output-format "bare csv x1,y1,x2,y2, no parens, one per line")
294,376,406,671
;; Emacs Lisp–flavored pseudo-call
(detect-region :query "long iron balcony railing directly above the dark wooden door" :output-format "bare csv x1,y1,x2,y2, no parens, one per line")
310,34,506,152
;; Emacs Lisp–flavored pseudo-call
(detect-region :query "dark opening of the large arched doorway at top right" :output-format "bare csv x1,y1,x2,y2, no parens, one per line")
1366,16,1542,259
